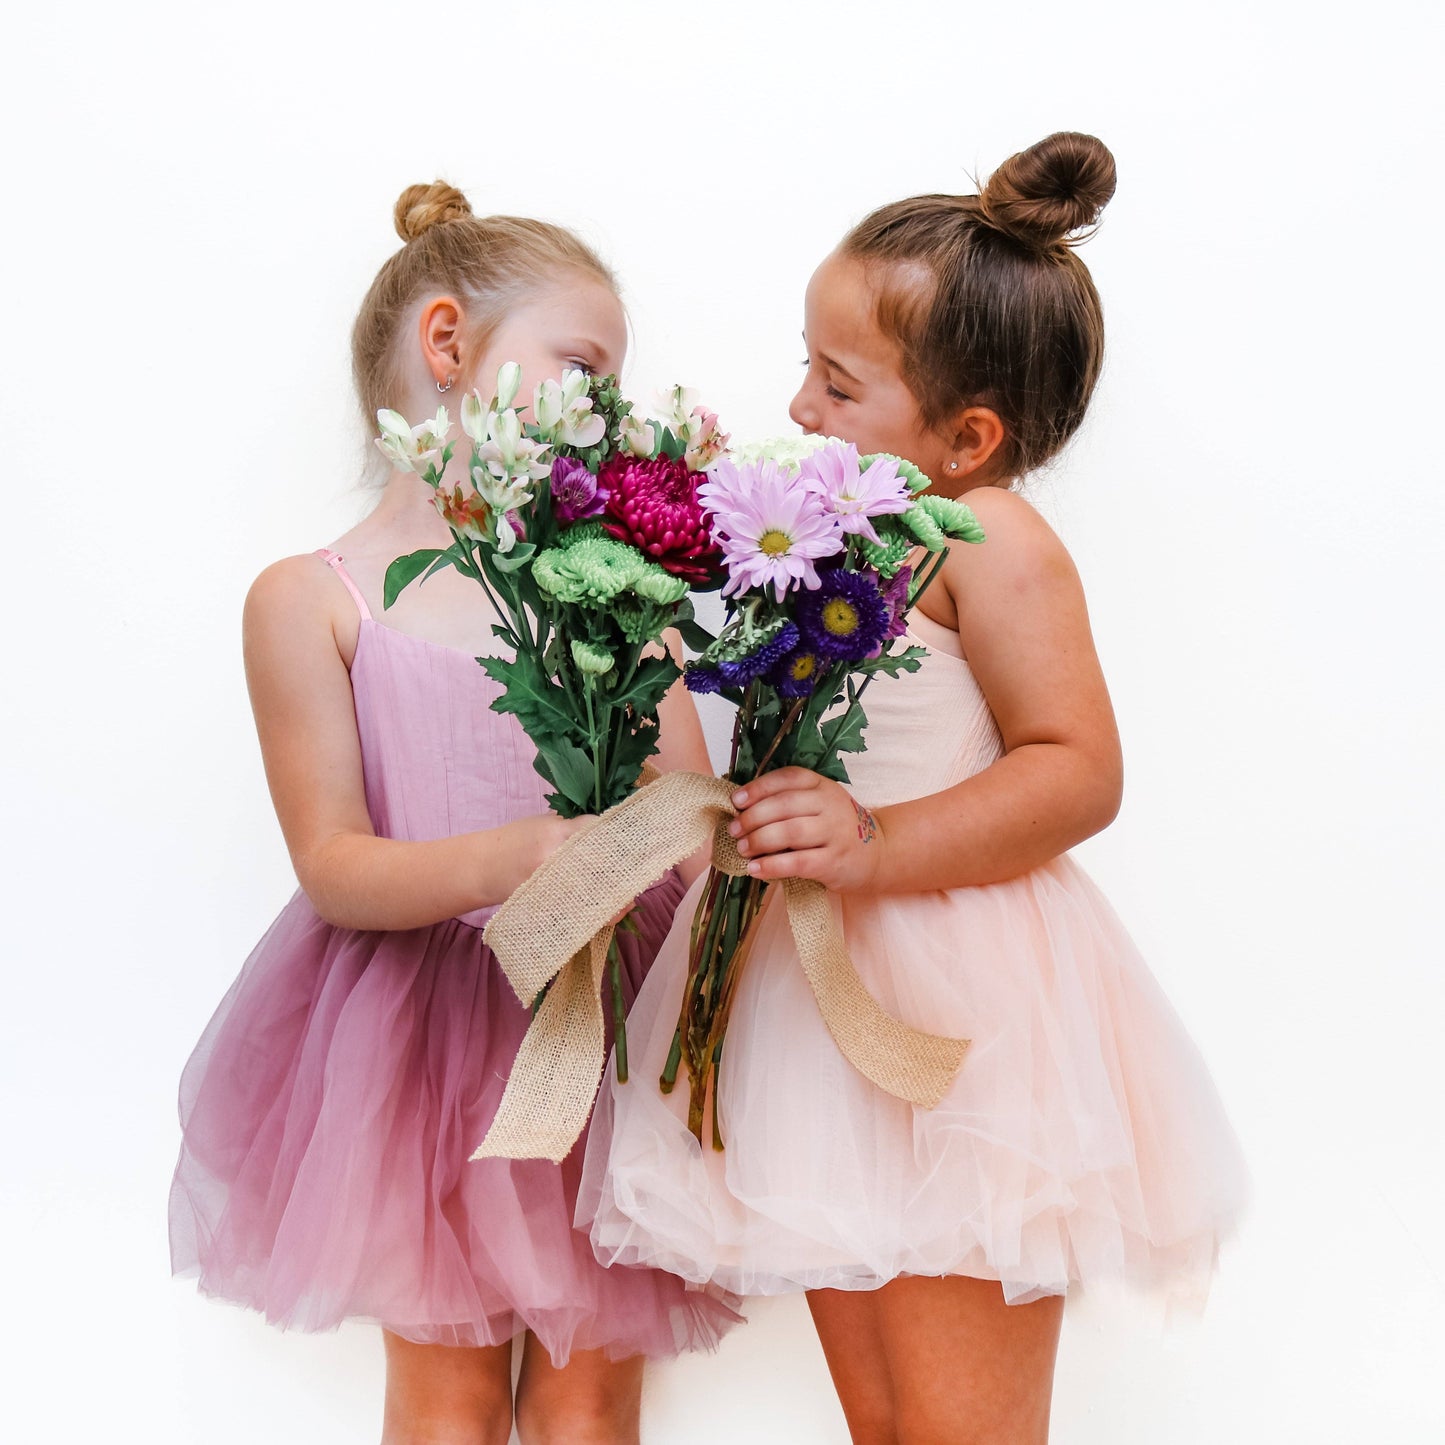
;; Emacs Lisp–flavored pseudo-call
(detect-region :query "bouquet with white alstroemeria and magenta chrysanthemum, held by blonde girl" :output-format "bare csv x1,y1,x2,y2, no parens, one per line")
377,363,727,1087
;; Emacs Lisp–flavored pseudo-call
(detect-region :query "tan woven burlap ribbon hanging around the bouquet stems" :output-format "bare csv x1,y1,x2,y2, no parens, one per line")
471,773,968,1160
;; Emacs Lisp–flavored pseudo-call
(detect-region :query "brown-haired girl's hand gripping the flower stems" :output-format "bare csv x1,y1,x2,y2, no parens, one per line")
728,767,883,890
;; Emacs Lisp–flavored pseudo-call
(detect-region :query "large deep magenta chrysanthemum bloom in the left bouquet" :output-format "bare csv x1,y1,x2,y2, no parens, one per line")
597,452,720,585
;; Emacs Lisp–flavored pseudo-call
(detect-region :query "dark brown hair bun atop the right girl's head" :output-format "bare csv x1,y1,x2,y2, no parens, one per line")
978,130,1116,251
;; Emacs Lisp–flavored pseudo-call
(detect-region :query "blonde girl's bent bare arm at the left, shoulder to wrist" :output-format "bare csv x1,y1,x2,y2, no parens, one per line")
243,556,578,929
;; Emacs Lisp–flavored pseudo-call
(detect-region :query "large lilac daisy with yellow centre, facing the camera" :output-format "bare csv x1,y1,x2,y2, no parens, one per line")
698,461,844,601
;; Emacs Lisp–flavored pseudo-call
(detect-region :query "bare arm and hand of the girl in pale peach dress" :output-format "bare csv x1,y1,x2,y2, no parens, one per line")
734,488,1123,892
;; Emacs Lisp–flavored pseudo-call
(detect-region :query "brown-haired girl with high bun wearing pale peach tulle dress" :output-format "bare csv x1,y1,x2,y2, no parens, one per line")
582,133,1243,1445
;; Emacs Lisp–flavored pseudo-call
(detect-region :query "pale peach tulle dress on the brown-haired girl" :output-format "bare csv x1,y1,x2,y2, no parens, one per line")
578,614,1244,1303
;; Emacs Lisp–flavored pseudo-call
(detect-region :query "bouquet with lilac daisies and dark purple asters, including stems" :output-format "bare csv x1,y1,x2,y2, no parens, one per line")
662,438,984,1149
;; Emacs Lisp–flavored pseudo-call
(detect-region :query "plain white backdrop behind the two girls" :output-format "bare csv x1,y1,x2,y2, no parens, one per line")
0,0,1445,1445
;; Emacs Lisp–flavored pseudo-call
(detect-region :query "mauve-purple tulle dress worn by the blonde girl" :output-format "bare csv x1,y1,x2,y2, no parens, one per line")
171,555,737,1364
